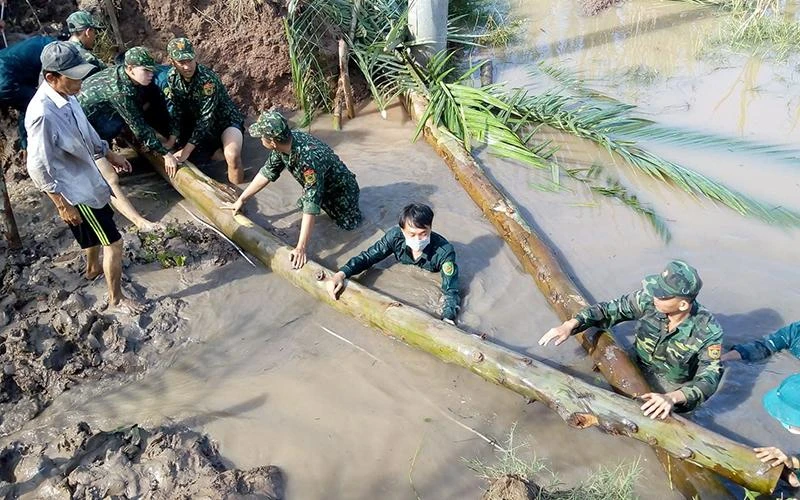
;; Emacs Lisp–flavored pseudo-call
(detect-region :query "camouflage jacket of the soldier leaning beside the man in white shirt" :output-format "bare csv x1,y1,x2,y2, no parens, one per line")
78,65,167,155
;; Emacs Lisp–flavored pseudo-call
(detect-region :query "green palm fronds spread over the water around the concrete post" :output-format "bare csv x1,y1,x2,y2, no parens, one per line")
286,0,800,241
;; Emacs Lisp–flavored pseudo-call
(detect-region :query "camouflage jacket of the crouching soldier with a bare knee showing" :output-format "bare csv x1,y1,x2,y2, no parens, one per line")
164,64,244,146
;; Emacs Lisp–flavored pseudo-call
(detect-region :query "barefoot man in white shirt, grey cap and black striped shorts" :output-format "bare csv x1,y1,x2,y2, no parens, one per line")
25,42,144,314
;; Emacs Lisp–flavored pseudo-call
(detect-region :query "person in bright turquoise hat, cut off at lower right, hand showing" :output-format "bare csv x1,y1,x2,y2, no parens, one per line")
753,374,800,488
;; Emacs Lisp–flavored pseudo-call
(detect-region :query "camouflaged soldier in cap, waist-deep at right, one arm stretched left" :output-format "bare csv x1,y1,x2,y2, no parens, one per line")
539,260,722,418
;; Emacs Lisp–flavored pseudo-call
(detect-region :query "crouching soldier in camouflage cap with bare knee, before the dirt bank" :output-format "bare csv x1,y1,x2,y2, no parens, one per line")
159,38,244,184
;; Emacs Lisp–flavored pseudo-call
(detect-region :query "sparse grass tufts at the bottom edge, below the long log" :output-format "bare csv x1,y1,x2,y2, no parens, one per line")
464,426,642,500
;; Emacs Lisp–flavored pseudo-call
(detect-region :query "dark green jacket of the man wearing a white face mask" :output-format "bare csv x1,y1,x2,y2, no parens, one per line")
339,226,459,320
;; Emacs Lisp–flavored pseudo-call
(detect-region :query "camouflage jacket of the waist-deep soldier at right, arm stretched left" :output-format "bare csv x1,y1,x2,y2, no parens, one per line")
575,289,722,411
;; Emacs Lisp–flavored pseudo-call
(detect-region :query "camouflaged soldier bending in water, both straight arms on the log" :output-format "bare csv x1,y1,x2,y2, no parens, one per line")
224,111,361,269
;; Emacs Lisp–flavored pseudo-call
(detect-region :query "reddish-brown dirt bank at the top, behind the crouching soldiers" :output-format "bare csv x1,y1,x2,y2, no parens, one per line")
97,0,295,114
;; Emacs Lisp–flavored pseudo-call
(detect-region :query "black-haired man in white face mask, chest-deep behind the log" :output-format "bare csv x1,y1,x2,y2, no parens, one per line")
326,203,459,324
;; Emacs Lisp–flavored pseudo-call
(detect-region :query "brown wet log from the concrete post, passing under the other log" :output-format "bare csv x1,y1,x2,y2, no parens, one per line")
406,94,779,498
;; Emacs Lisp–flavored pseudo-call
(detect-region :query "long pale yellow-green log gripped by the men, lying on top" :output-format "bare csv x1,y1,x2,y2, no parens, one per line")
145,154,774,491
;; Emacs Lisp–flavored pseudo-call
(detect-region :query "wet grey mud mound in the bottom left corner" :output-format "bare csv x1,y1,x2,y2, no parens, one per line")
0,423,284,500
